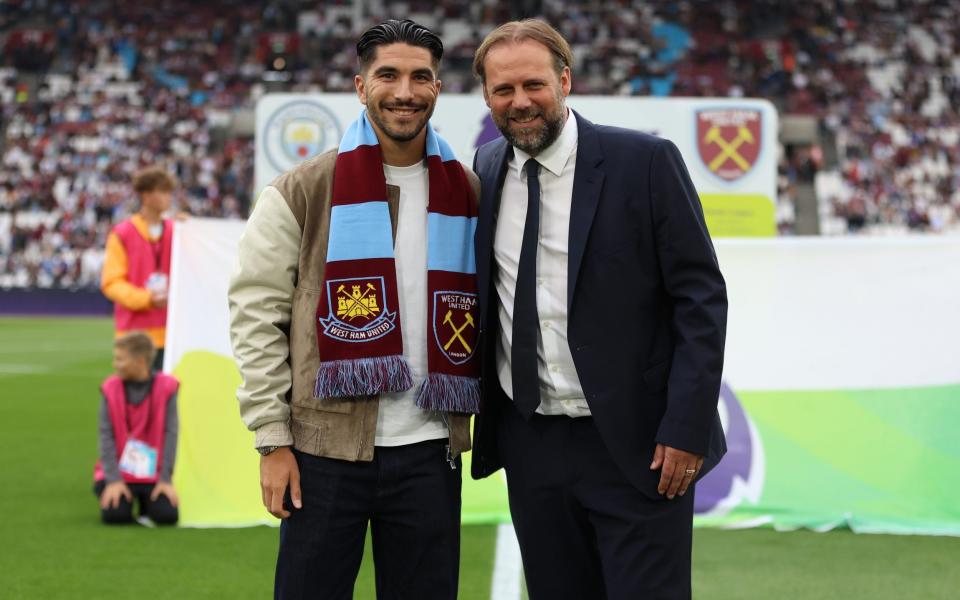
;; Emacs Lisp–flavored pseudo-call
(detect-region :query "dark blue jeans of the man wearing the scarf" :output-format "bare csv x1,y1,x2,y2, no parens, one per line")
274,439,461,600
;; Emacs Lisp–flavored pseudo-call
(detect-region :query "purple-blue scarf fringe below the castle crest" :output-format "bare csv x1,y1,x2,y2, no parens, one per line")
313,355,413,398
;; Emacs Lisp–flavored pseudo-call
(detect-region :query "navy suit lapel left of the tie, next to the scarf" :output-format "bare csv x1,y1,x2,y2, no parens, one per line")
476,138,510,324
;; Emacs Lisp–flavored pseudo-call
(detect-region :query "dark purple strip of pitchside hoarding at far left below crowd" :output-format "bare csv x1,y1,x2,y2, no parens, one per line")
0,288,113,317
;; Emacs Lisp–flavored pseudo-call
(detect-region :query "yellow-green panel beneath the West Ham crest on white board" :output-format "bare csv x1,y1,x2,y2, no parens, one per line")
700,193,777,238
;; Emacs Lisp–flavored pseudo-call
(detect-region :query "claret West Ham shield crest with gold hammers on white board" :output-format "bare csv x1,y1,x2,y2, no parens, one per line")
696,108,763,181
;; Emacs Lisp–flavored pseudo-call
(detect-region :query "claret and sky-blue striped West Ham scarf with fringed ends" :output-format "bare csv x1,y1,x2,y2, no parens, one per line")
315,112,480,413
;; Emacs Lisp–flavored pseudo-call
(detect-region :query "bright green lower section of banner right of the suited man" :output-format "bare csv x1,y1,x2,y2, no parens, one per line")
698,385,960,535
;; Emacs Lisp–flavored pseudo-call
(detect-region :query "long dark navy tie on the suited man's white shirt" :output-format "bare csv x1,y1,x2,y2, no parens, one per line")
510,158,540,419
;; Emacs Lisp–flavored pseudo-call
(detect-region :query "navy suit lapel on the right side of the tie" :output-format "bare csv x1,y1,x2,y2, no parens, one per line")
567,111,604,318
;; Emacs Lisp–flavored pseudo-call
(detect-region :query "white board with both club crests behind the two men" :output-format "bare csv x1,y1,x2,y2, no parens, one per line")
255,94,778,237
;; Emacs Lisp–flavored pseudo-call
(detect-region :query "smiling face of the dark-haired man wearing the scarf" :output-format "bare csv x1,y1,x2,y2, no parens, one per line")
354,43,440,149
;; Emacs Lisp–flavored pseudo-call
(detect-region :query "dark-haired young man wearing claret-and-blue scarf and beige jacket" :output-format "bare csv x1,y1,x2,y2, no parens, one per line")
229,20,479,599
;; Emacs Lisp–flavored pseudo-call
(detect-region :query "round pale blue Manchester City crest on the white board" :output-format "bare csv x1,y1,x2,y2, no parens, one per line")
263,100,343,172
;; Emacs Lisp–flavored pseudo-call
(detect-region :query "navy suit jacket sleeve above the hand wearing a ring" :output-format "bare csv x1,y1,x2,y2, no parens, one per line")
649,140,727,455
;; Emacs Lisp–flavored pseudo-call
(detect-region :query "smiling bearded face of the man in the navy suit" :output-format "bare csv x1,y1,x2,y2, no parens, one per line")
483,40,571,156
